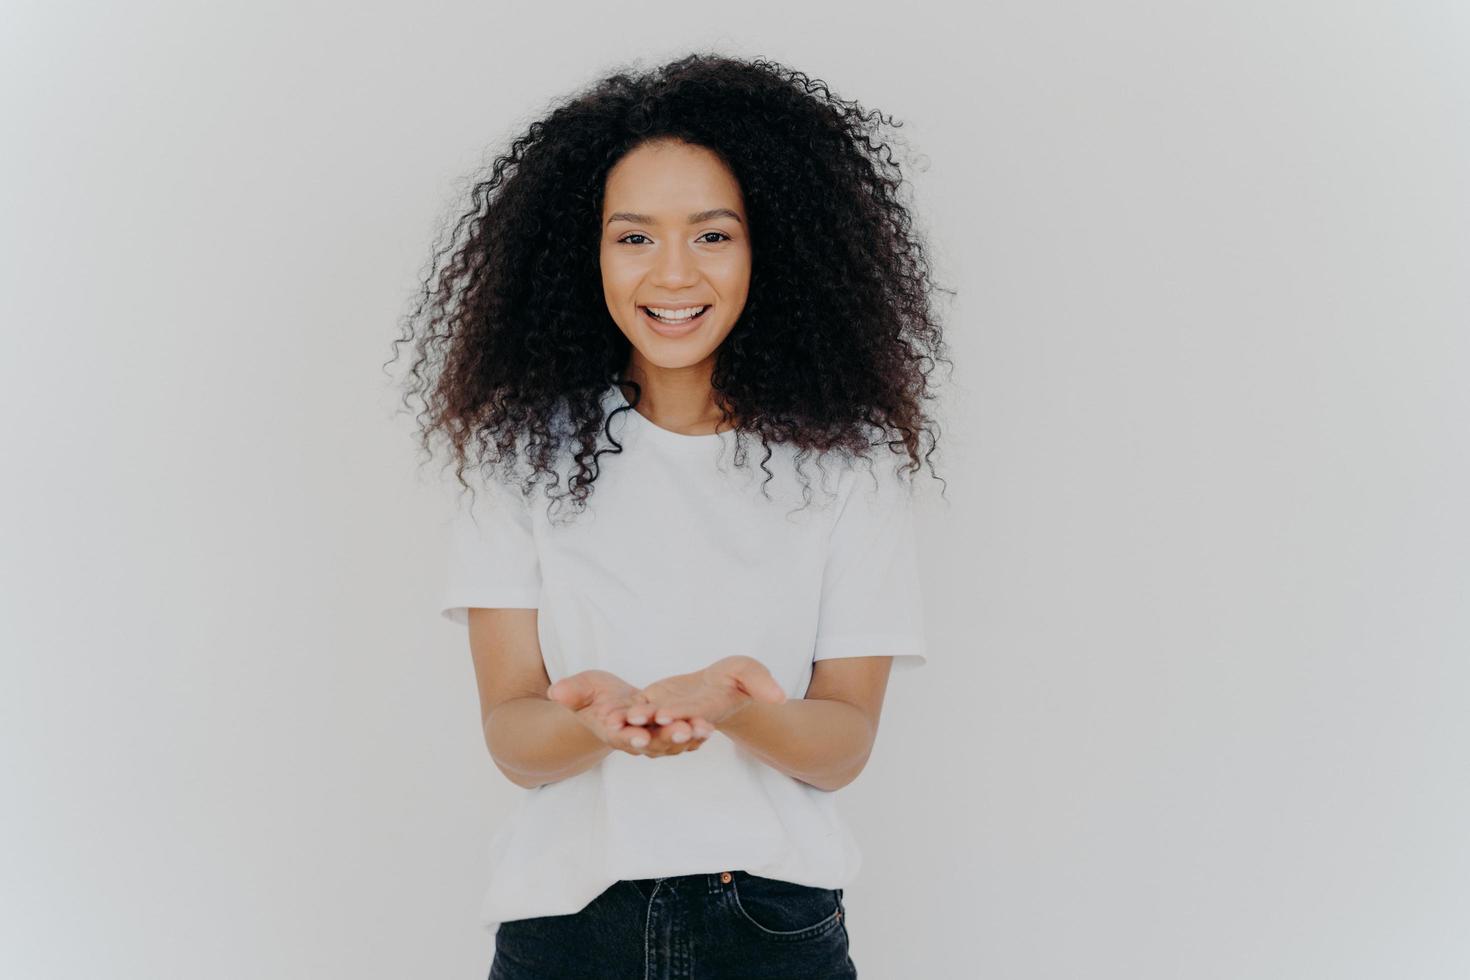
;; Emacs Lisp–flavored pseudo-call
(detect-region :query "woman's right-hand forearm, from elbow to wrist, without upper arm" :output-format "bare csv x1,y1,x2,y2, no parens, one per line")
714,698,878,790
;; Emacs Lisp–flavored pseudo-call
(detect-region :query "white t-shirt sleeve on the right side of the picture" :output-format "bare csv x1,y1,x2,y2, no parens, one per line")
811,450,928,671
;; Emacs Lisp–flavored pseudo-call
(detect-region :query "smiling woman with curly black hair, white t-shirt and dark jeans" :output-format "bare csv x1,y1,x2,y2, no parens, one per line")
400,54,944,980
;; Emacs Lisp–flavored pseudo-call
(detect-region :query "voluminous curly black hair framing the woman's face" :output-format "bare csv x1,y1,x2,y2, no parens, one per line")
394,53,950,520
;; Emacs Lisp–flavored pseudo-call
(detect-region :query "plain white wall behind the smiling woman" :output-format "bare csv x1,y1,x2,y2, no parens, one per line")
0,0,1470,980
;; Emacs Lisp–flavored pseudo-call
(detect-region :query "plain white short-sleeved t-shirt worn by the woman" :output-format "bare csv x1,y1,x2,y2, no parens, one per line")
441,385,926,932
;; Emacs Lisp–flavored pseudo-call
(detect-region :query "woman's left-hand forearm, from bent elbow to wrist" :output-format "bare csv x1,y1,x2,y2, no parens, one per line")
485,696,613,789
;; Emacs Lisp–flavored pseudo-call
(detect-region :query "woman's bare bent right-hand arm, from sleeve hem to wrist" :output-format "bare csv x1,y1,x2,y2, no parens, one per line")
714,657,894,790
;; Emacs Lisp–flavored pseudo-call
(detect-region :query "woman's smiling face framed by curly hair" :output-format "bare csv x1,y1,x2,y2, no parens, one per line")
601,141,751,369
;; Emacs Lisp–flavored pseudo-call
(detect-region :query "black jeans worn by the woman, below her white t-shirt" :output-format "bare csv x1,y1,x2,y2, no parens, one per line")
490,871,857,980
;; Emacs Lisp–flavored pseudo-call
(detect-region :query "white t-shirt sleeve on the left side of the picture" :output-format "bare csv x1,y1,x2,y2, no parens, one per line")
440,480,541,626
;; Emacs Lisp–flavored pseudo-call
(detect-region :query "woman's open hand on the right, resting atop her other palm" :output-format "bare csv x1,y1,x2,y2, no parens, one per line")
622,655,786,734
